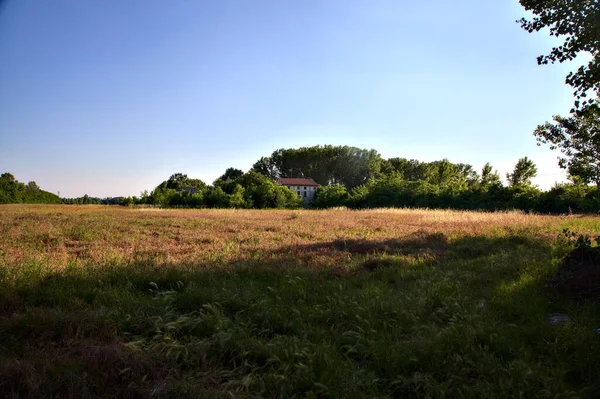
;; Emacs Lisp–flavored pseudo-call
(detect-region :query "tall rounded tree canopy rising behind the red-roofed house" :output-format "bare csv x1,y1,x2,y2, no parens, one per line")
252,145,383,189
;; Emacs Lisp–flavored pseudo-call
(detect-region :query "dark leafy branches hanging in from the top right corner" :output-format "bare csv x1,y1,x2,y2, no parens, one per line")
517,0,600,110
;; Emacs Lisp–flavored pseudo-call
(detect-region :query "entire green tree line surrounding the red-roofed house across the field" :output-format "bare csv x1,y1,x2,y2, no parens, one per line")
108,140,600,213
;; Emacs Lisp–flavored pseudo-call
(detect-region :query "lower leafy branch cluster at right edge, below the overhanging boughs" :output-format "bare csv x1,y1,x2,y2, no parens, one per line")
533,107,600,188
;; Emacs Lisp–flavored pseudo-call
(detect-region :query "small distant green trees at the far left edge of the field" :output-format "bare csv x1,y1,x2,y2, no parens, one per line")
0,173,61,204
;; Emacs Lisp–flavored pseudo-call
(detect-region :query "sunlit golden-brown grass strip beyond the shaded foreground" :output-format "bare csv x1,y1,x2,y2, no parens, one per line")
0,205,576,276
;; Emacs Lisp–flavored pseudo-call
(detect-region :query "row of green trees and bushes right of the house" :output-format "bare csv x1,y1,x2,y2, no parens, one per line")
314,157,600,213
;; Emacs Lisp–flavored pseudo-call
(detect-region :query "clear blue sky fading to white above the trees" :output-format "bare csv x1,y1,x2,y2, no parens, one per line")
0,0,592,197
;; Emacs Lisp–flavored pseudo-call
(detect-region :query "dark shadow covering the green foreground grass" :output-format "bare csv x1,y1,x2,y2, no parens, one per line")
0,233,599,397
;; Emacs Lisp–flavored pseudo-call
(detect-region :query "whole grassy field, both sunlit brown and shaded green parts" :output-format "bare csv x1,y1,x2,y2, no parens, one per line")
0,206,600,398
